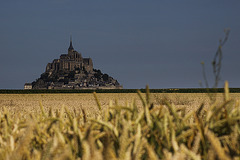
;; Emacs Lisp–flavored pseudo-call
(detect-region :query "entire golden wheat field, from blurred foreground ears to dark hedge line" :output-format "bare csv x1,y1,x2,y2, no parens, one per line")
0,83,240,160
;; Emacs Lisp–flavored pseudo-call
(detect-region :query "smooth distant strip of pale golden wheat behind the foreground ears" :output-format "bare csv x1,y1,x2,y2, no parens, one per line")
0,93,240,114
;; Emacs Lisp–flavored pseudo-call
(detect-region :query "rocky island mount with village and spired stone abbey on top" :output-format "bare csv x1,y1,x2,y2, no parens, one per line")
24,38,122,89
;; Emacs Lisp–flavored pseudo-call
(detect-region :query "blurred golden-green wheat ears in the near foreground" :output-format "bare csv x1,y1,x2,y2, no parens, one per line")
0,82,240,160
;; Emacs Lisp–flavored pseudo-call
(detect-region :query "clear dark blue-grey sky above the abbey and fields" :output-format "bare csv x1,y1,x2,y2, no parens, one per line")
0,0,240,89
